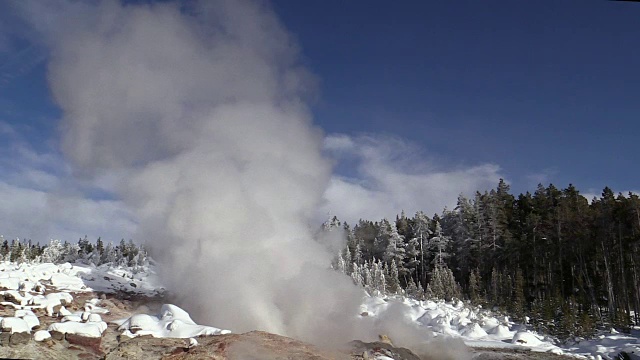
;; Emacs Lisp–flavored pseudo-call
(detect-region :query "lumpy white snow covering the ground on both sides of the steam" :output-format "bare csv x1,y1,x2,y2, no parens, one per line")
0,262,640,359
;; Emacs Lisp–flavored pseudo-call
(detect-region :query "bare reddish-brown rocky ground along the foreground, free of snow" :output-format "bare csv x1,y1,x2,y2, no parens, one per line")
0,286,580,360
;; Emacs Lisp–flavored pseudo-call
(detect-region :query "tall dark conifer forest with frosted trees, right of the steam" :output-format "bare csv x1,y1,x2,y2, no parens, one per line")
323,180,640,337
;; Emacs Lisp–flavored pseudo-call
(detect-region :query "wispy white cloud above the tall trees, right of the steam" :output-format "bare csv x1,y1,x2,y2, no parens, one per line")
321,134,503,224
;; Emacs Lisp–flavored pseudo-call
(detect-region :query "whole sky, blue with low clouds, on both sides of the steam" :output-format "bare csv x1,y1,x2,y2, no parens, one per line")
0,0,640,242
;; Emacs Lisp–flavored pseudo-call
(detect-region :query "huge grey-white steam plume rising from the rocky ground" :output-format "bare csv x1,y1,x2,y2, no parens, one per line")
36,1,361,342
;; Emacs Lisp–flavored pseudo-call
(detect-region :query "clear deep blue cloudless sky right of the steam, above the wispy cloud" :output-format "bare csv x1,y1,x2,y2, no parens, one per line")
275,1,640,191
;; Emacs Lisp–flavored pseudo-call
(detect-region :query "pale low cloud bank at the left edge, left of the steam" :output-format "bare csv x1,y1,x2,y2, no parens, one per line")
0,126,137,243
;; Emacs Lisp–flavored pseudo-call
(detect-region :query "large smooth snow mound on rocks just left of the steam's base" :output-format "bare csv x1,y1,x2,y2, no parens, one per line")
116,304,230,339
